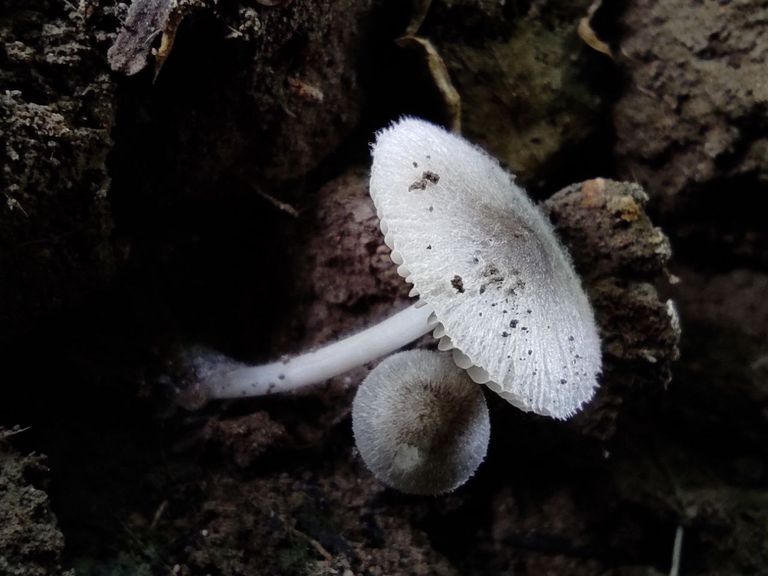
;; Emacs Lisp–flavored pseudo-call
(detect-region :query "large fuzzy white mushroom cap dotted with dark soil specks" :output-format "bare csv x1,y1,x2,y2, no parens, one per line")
370,118,601,418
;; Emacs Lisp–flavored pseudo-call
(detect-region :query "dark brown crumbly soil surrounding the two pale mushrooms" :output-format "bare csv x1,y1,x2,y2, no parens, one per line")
0,0,768,576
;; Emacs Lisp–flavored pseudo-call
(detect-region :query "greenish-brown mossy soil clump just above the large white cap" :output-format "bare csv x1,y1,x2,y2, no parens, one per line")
443,19,600,178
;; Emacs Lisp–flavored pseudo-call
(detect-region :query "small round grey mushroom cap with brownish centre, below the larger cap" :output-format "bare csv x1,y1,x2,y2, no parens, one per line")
352,350,491,494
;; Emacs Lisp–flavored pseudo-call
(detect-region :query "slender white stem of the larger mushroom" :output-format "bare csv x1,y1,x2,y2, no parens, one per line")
201,303,436,399
